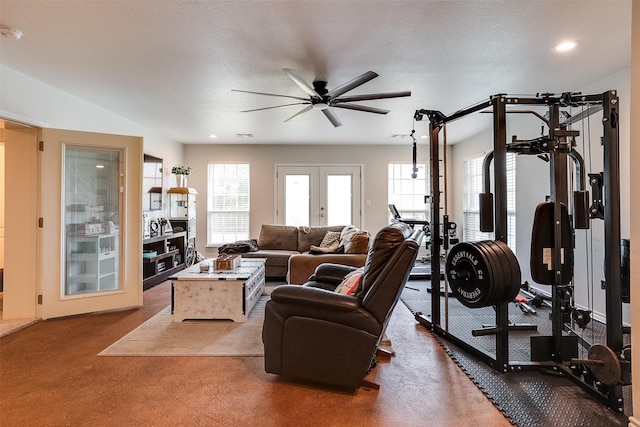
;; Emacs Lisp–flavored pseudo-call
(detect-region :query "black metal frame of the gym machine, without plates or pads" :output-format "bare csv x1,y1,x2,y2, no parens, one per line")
414,91,631,412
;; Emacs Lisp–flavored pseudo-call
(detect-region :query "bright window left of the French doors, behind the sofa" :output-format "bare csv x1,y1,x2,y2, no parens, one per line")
207,163,249,246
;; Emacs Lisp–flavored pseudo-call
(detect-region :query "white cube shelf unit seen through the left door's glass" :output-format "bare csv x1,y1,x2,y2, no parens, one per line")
65,234,119,295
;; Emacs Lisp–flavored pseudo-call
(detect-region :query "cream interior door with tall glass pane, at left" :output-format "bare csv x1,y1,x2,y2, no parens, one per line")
38,129,142,319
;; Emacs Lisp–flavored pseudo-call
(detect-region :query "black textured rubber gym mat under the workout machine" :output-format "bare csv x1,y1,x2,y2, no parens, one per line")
401,281,631,427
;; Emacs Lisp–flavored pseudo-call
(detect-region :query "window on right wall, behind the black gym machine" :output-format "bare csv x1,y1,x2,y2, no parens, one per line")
463,153,516,252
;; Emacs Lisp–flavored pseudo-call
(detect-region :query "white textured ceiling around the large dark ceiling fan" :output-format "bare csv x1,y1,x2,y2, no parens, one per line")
0,0,631,144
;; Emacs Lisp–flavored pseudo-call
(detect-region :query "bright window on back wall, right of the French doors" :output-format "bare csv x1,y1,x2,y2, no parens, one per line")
388,163,429,221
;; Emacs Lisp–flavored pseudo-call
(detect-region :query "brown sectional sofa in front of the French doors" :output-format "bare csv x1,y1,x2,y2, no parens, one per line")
242,224,368,284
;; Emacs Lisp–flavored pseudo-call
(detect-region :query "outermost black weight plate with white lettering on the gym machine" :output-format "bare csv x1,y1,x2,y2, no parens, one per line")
445,242,492,308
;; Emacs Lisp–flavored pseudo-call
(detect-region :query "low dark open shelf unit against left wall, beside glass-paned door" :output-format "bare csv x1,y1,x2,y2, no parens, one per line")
142,231,187,290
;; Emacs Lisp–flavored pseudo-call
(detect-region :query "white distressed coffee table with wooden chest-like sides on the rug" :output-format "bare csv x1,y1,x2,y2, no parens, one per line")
169,258,266,322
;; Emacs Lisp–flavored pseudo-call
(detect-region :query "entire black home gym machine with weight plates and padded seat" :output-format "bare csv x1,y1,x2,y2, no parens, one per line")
414,91,631,412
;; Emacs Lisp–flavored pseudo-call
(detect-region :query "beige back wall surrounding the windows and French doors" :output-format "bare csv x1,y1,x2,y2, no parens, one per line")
184,144,428,255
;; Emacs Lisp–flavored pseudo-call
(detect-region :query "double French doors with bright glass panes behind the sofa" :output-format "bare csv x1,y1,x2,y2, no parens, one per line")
276,165,362,227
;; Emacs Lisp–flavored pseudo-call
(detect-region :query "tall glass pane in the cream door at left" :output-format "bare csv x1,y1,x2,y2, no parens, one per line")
63,146,121,296
